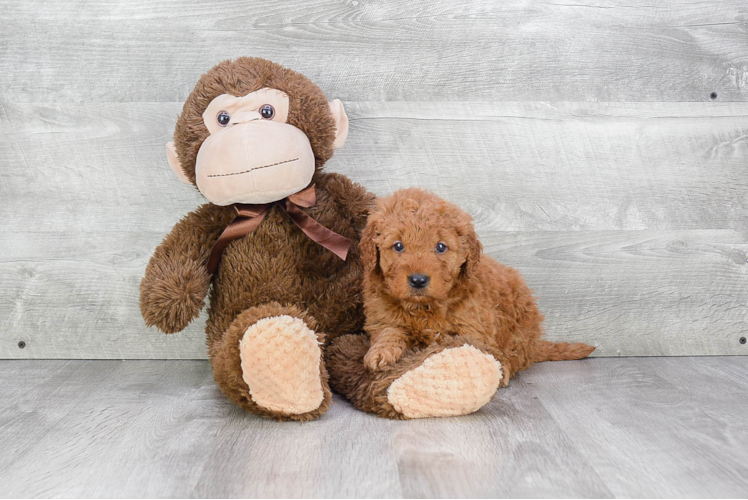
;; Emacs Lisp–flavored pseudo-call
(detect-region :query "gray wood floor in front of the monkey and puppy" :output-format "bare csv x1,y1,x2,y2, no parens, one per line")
0,357,748,498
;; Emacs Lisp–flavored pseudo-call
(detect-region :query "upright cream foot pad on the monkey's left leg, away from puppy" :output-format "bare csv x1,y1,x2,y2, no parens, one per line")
239,316,324,415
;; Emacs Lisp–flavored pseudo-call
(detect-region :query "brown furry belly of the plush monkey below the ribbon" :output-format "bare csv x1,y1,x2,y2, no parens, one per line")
206,207,364,346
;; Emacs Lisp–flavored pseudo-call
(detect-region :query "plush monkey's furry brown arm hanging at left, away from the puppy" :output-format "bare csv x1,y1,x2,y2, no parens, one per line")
140,203,236,333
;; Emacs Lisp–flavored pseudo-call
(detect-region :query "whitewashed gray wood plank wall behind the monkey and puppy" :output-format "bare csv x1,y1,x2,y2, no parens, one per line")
0,0,748,358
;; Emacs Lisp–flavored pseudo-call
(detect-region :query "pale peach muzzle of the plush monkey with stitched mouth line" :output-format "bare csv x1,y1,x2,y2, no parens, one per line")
195,120,314,205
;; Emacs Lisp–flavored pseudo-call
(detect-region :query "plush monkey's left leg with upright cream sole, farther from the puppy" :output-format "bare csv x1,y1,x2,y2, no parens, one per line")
209,303,330,421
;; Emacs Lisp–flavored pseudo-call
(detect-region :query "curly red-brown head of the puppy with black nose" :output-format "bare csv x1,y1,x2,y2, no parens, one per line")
361,188,482,303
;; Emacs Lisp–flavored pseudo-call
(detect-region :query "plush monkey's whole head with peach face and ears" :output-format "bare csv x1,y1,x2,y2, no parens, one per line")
166,57,348,205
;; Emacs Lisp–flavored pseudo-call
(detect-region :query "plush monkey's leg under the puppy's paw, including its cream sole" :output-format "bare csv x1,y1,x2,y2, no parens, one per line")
325,335,508,419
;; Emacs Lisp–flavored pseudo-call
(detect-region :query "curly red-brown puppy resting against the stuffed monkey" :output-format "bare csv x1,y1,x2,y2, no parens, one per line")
361,189,594,385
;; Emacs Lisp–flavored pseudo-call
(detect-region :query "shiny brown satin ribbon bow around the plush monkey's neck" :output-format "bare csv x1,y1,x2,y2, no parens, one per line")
208,184,351,274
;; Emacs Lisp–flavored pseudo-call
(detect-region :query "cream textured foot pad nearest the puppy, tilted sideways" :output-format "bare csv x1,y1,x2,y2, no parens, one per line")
387,345,502,418
